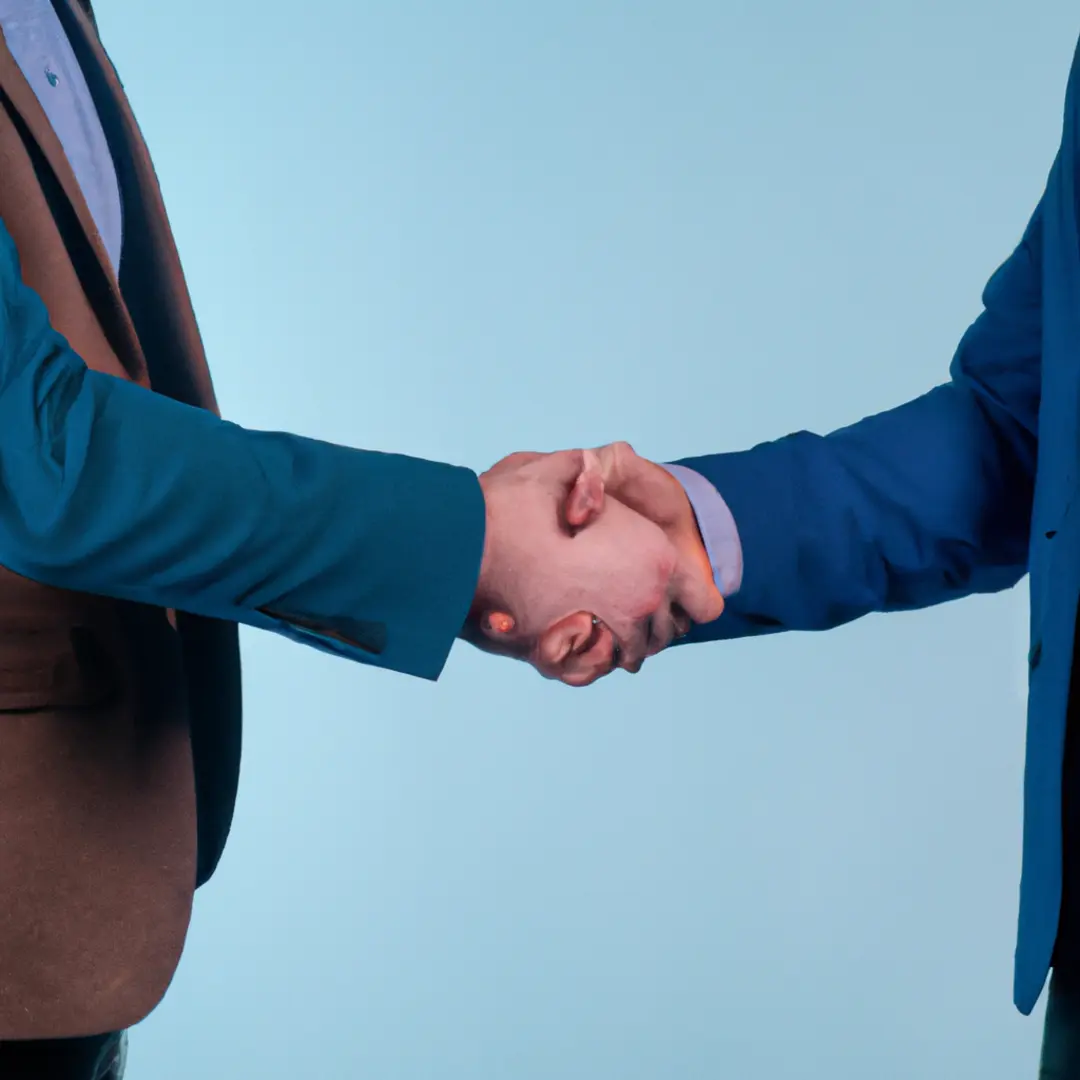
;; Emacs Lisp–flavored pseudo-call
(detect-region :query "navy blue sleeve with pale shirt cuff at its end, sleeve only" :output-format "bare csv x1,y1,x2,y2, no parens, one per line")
679,196,1043,640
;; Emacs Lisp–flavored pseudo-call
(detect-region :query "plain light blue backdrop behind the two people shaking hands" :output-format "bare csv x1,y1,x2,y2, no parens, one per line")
98,0,1080,1080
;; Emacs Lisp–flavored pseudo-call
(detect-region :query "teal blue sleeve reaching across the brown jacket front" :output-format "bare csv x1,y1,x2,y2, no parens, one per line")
0,224,485,678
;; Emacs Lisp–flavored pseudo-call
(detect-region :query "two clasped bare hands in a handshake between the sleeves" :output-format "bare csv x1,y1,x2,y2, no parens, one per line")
461,443,724,686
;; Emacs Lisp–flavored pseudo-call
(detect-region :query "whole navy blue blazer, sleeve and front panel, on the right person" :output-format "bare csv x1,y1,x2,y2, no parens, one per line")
680,35,1080,1013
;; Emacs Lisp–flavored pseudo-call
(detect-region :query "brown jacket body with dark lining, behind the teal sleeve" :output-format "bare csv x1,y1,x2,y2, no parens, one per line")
0,0,240,1040
